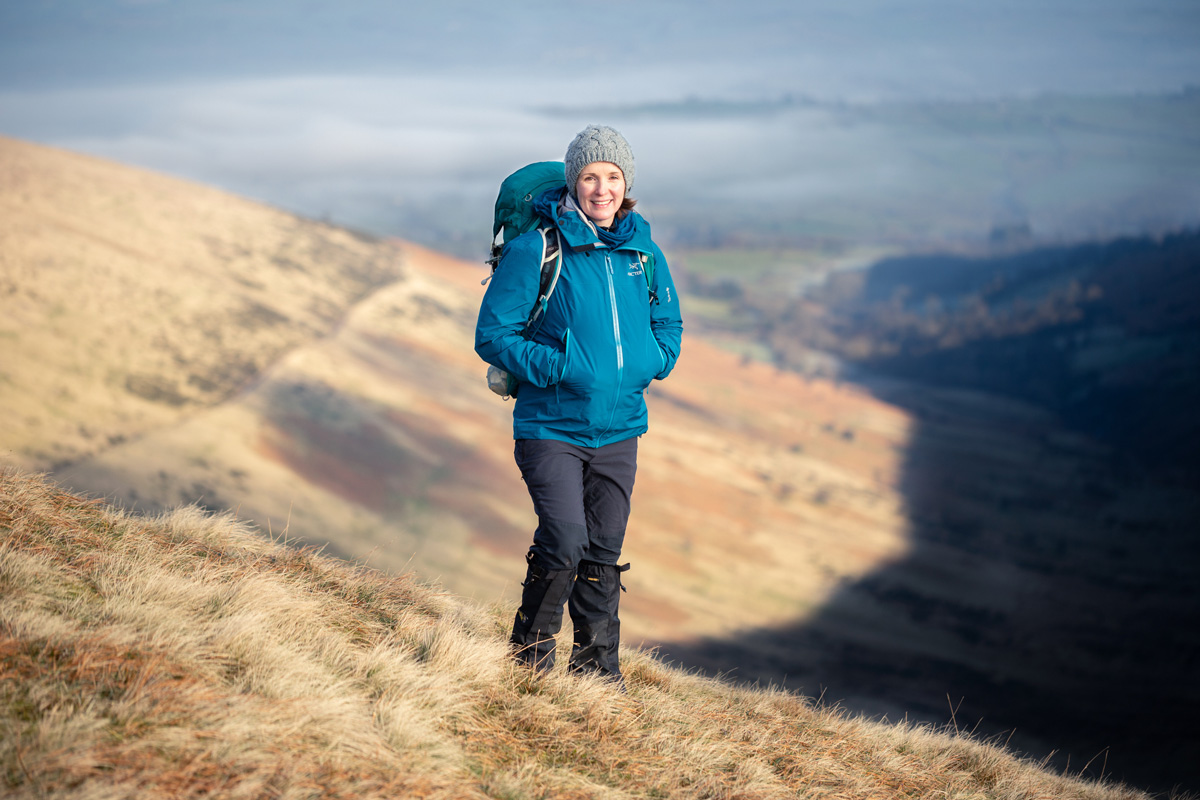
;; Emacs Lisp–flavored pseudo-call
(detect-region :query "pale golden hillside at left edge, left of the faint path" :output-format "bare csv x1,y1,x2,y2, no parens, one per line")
0,138,401,468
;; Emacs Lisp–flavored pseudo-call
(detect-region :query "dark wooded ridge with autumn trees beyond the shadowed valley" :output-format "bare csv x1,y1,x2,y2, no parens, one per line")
734,231,1200,470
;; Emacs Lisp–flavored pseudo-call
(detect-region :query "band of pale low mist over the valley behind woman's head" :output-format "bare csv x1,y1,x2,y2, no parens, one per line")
0,59,1194,252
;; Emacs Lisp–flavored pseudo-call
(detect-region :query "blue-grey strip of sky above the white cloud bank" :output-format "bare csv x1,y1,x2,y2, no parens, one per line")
0,0,1200,101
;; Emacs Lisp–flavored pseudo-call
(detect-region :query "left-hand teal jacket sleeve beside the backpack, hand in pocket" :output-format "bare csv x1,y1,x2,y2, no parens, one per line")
475,231,565,387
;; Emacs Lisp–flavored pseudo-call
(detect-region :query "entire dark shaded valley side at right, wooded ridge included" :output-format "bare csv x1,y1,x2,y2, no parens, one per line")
664,231,1200,789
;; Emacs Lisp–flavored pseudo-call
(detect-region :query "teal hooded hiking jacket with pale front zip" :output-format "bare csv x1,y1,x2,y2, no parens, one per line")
475,188,683,447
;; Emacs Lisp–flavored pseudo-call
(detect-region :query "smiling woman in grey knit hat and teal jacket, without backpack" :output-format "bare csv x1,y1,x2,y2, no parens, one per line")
475,126,683,685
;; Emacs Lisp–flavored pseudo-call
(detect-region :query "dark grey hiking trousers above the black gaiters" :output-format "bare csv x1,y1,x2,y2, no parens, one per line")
514,437,637,570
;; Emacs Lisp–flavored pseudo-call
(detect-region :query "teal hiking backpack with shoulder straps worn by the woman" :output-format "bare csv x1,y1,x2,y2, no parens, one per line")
481,161,655,398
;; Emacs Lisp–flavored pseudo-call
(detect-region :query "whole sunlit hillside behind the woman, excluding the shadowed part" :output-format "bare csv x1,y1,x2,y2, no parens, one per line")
0,142,908,642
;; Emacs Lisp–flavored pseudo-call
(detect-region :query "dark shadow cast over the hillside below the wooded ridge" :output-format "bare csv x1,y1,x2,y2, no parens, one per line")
660,248,1200,792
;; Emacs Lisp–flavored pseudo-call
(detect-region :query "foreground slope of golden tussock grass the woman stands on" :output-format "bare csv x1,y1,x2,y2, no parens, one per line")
0,471,1146,800
